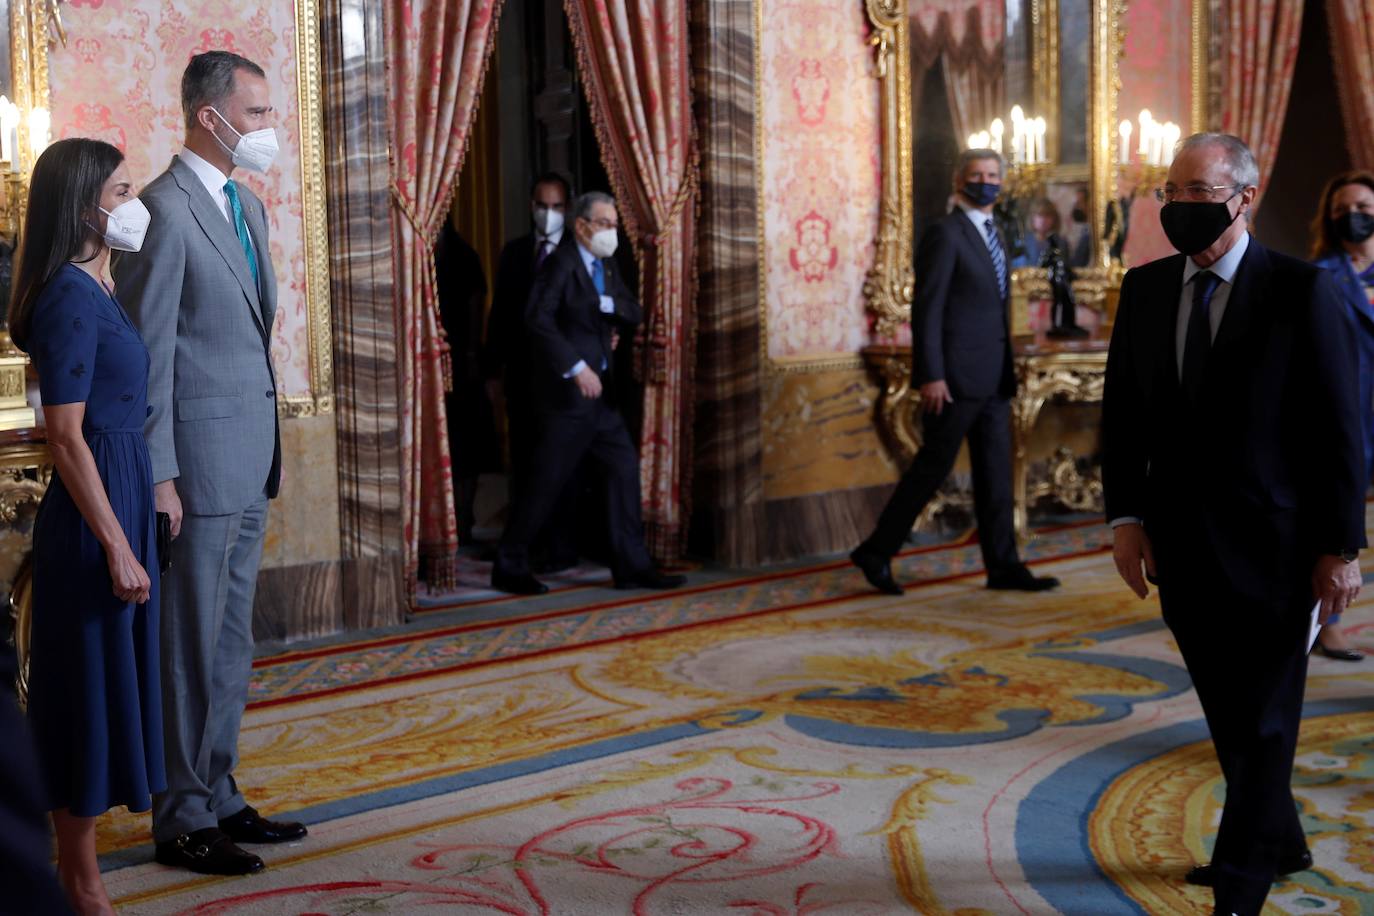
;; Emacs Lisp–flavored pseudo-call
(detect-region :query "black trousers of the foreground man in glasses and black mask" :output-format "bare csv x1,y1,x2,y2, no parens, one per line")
1151,531,1315,916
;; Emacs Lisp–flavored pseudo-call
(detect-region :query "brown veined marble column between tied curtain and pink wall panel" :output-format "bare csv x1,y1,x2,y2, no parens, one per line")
691,0,764,566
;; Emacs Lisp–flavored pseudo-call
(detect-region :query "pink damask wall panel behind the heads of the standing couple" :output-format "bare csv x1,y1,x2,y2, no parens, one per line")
49,0,312,397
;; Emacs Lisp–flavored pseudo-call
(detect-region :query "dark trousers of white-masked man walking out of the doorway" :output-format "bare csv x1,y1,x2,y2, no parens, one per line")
496,398,651,577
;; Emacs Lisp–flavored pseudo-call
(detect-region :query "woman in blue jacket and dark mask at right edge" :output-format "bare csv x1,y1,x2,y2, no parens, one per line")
1312,172,1374,662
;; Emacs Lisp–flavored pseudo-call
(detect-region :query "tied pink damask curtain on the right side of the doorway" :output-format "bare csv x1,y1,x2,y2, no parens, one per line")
565,0,697,560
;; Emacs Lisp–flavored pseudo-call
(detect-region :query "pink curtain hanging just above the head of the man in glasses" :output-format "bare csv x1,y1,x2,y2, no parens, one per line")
1221,0,1303,202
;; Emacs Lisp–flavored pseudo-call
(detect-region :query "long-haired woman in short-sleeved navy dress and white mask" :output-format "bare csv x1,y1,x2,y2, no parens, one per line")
10,139,166,913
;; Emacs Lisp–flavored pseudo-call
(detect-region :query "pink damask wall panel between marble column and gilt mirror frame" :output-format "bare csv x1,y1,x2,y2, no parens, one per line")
756,0,881,360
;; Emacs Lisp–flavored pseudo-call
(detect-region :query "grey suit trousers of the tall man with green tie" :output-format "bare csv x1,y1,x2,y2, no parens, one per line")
153,492,268,843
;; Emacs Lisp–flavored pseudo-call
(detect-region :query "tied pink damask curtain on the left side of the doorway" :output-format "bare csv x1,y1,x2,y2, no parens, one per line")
386,0,500,592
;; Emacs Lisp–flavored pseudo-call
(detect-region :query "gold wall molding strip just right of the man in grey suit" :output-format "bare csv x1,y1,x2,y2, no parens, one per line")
278,0,334,417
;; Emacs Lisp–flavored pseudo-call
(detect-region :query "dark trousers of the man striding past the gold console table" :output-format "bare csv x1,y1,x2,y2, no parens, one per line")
859,397,1021,574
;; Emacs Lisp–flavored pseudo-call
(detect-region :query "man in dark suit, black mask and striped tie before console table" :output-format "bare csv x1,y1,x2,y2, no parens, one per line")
849,150,1059,595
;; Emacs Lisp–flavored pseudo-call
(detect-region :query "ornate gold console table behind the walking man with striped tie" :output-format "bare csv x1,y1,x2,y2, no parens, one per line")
863,335,1107,541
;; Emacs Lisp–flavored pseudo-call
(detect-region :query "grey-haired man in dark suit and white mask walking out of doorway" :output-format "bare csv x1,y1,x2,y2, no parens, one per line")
492,191,686,595
